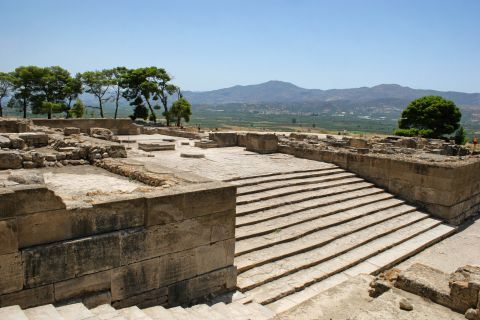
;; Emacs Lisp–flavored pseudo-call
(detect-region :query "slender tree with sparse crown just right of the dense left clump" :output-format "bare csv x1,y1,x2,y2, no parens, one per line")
81,70,113,118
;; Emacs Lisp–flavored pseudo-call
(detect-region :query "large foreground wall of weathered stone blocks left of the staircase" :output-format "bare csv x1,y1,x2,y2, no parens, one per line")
0,182,236,308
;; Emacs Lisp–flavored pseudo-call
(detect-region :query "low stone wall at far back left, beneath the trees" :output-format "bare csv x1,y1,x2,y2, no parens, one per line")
32,119,140,135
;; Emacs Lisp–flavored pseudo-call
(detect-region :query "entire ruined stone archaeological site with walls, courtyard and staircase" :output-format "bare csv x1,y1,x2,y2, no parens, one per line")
0,118,480,320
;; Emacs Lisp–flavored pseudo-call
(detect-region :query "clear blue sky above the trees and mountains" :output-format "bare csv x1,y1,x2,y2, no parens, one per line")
0,0,480,92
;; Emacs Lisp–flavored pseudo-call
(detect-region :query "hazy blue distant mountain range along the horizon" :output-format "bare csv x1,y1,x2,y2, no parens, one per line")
183,81,480,107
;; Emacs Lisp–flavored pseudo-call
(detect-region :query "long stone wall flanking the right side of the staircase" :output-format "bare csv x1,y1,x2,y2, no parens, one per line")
279,145,480,224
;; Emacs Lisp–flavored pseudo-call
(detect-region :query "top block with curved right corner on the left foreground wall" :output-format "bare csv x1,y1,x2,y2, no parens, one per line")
12,184,65,215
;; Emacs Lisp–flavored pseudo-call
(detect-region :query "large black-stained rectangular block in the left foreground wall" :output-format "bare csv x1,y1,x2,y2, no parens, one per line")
22,232,120,287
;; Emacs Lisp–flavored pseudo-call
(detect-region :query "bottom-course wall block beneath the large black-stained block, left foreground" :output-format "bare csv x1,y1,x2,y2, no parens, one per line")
54,270,112,301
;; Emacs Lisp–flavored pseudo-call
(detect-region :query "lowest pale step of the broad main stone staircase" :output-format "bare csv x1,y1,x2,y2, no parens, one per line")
246,223,452,305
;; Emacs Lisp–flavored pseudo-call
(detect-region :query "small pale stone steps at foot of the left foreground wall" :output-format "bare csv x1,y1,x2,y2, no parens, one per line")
0,302,275,320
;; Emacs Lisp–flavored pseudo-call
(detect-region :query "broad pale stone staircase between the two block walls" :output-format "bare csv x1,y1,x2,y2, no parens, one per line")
228,163,456,313
